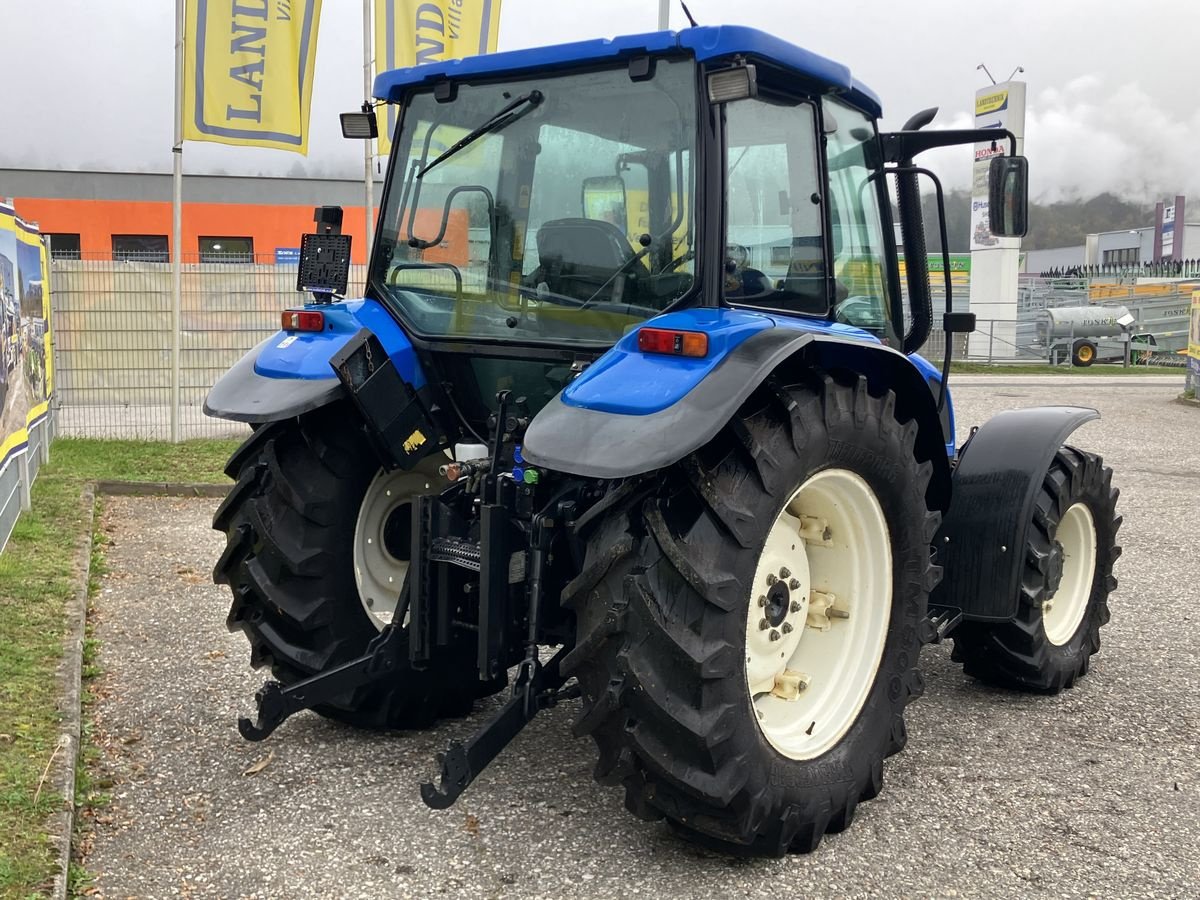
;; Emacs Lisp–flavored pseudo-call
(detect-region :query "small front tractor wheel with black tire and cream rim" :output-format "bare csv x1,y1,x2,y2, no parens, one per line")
954,446,1121,694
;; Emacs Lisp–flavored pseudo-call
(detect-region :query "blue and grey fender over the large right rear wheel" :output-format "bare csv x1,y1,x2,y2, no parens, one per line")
522,310,949,509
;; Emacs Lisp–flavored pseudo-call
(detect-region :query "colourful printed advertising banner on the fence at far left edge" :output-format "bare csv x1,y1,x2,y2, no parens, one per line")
0,204,53,468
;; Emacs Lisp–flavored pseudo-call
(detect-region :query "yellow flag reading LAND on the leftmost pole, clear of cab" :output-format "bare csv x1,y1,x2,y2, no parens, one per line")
181,0,322,155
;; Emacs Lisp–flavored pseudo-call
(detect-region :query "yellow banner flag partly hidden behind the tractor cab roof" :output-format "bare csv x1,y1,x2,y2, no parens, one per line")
376,0,500,156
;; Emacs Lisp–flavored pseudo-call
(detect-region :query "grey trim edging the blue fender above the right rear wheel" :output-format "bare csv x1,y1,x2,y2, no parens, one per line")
521,328,908,479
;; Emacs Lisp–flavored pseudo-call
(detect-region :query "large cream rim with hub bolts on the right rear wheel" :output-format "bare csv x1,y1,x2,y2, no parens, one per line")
745,469,892,760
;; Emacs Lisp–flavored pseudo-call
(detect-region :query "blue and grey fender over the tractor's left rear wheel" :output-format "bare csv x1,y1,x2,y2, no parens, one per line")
204,300,425,424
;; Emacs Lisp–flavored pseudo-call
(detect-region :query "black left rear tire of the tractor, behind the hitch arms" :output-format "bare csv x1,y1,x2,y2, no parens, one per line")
212,404,487,728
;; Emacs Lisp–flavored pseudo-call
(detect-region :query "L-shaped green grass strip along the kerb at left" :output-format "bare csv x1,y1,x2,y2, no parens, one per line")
0,439,238,900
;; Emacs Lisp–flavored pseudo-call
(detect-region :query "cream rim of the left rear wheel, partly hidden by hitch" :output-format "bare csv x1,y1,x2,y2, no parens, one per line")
354,469,432,629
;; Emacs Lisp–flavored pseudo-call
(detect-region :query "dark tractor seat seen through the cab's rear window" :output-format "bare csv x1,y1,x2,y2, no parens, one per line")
529,218,649,301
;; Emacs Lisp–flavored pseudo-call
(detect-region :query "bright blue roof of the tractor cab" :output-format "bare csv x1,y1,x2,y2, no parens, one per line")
373,25,881,116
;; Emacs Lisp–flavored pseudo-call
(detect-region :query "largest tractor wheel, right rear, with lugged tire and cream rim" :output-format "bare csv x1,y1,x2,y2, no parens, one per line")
564,379,940,856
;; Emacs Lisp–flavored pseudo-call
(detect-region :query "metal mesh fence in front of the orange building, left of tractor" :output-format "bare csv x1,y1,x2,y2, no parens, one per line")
50,257,366,440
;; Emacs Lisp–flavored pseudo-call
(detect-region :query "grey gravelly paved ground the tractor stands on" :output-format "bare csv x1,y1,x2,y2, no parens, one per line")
84,377,1200,899
